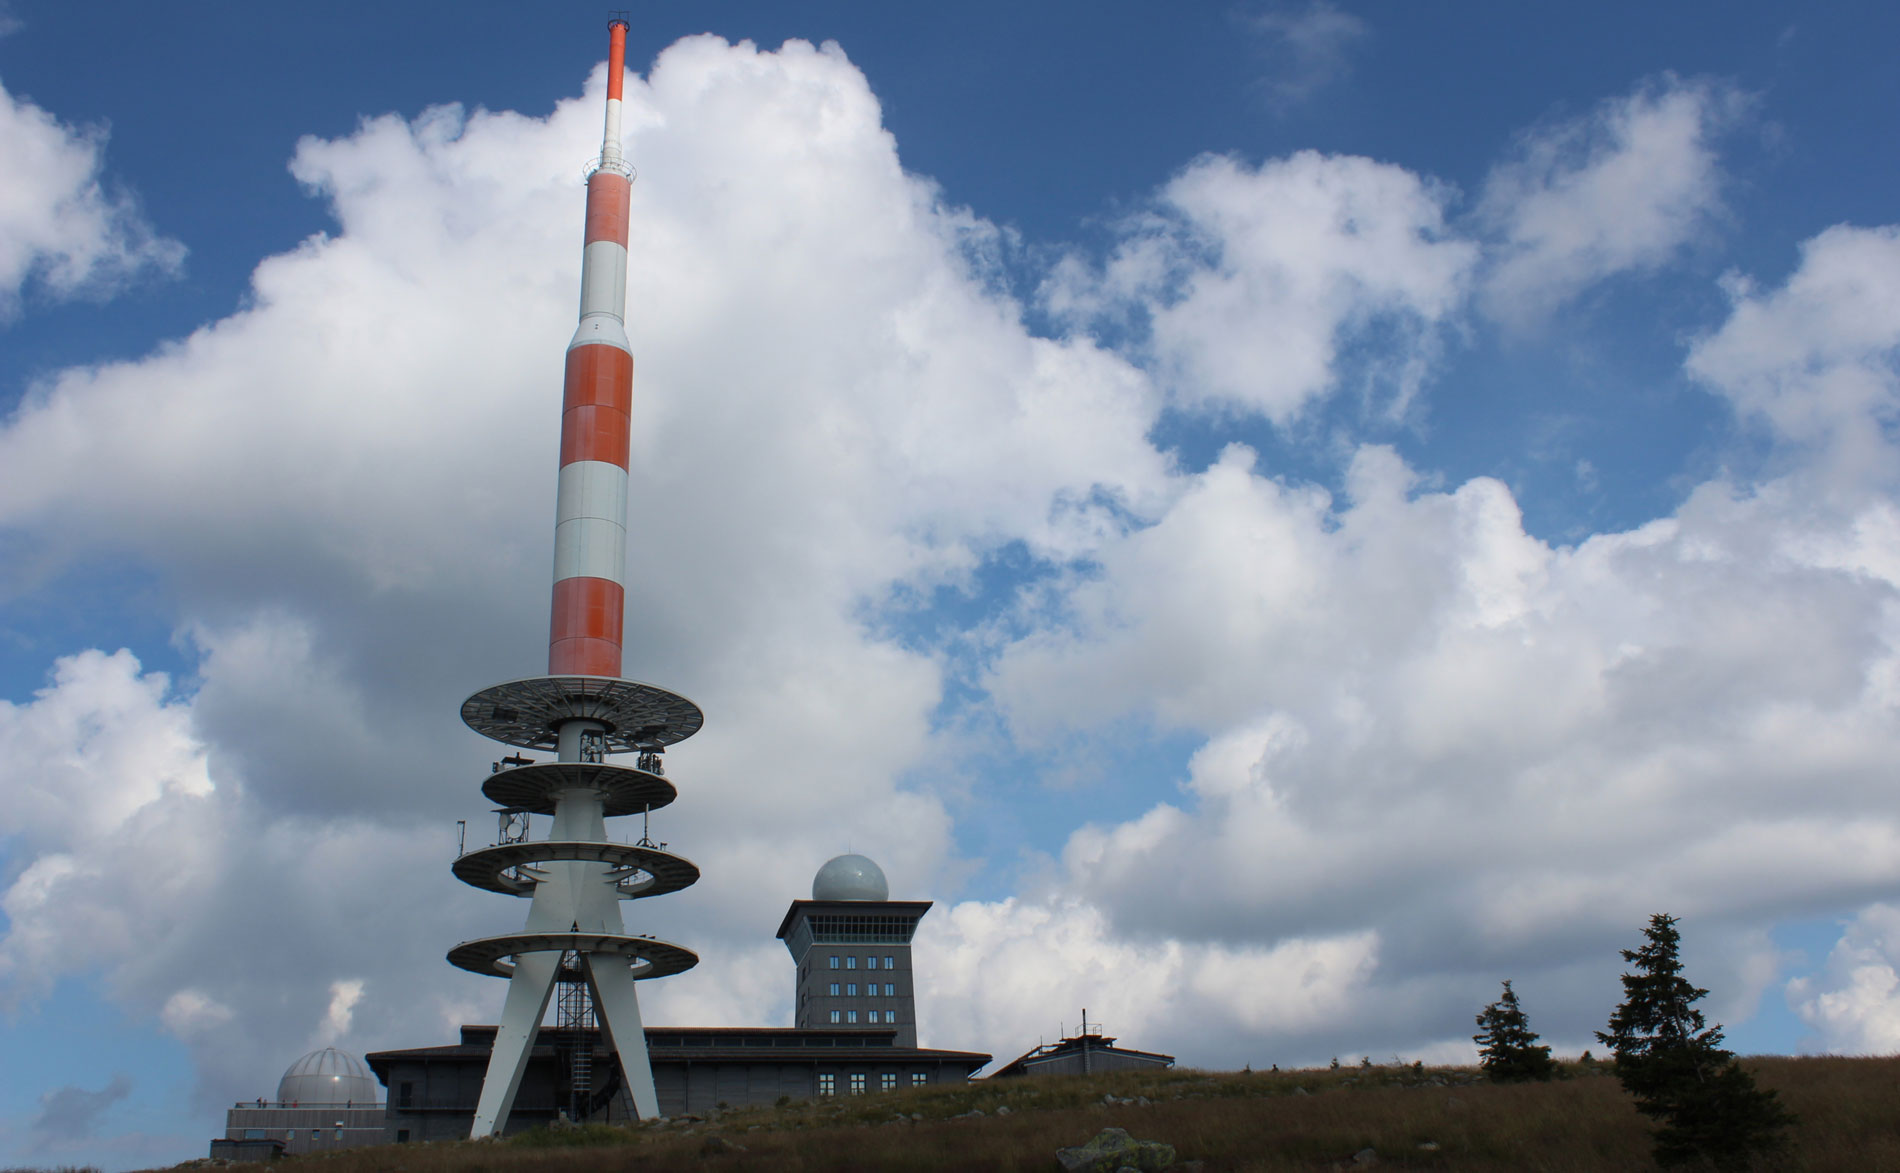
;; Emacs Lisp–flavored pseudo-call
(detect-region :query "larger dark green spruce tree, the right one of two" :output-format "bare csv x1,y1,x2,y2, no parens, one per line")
1596,913,1794,1169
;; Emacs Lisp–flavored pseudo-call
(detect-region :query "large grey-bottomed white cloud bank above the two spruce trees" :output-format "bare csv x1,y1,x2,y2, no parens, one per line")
986,279,1900,1059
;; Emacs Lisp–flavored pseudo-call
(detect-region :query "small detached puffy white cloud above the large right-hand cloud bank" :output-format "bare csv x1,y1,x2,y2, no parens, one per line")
1045,150,1476,424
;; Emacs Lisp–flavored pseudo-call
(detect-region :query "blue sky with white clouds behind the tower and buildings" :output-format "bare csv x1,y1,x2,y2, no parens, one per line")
0,2,1900,1167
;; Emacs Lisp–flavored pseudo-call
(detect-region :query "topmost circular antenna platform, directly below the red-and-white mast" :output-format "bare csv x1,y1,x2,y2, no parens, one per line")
462,677,705,753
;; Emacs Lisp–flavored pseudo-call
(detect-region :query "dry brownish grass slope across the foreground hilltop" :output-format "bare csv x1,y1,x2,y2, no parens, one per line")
140,1059,1900,1173
